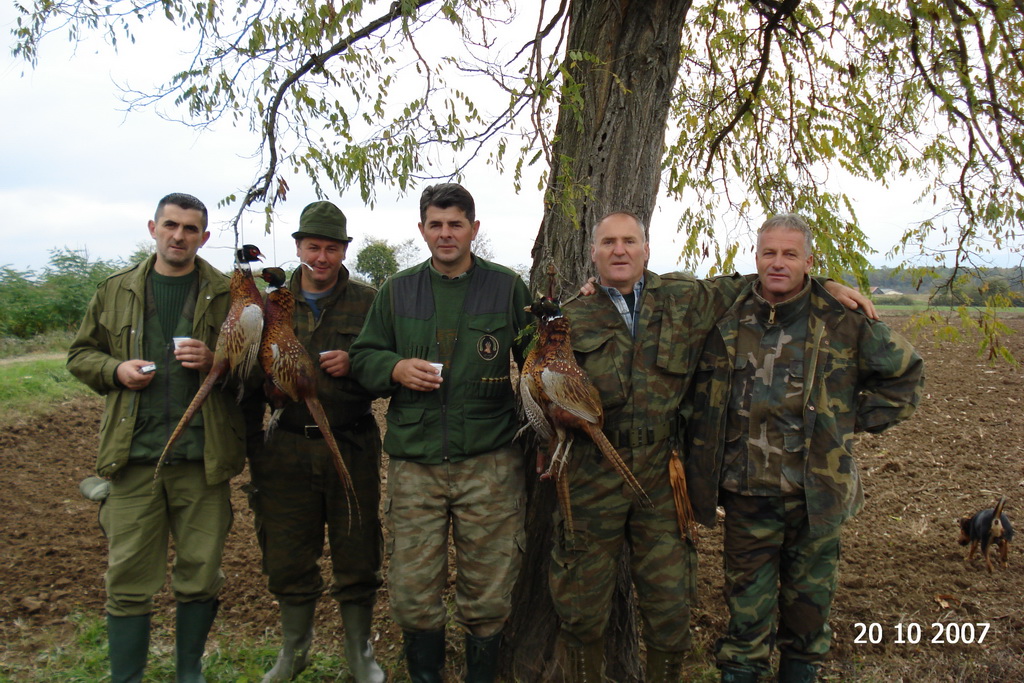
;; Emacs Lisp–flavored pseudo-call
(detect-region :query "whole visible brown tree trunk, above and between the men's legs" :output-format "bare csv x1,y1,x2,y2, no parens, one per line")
516,0,690,682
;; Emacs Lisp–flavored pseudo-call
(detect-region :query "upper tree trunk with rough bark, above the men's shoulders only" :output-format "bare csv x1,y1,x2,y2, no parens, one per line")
531,0,690,295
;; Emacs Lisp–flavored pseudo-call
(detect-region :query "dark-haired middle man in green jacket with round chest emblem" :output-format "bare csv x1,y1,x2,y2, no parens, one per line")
351,183,529,683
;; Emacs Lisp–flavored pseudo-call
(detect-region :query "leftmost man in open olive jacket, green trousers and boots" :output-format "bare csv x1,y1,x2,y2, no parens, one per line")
68,194,245,683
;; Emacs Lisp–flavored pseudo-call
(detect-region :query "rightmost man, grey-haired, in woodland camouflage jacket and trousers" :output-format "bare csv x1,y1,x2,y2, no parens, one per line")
683,214,923,683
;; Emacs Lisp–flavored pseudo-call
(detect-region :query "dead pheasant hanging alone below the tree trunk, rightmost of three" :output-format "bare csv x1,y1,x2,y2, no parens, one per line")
519,296,651,537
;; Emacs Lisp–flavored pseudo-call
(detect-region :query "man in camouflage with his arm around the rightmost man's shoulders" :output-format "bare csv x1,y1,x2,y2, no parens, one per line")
550,212,867,683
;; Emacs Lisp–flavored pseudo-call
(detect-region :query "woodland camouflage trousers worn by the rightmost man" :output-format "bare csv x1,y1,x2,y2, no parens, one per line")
717,492,840,672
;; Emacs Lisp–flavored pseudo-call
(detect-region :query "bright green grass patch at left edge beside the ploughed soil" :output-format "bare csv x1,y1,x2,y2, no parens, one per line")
0,356,95,423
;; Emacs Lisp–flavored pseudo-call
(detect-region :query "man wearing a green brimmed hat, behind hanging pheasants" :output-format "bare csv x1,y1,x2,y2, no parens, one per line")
249,202,384,683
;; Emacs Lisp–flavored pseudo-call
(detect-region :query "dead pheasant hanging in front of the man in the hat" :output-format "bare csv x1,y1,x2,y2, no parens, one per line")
259,267,354,507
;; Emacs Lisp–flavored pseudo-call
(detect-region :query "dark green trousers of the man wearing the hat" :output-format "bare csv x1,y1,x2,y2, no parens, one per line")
247,416,384,605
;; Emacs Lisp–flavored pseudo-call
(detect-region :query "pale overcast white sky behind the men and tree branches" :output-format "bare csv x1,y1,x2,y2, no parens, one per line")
0,0,991,274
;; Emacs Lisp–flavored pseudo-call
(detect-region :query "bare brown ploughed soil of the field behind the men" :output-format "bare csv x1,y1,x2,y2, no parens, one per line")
0,319,1024,681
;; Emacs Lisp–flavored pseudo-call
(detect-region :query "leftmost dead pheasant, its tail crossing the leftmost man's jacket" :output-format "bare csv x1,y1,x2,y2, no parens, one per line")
153,245,263,479
